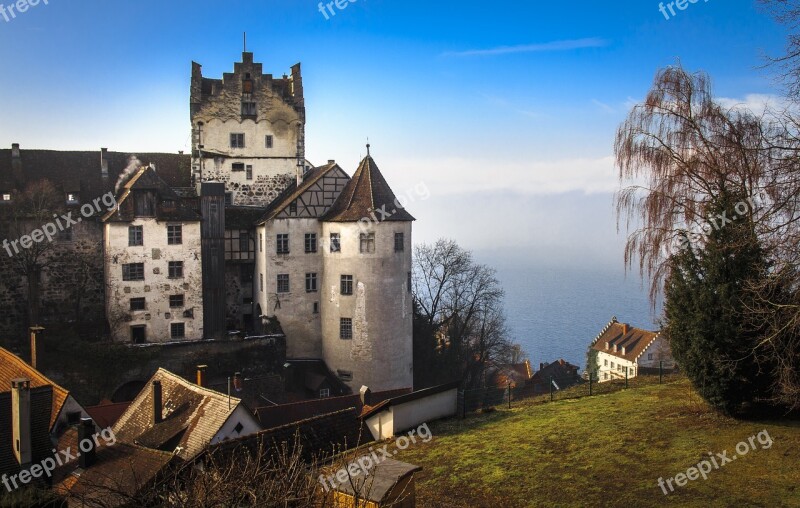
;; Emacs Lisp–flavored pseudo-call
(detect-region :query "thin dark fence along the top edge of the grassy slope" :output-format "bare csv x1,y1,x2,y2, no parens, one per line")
457,368,678,418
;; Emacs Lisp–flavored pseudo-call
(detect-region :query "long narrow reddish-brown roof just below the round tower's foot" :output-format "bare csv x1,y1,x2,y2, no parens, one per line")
256,388,411,429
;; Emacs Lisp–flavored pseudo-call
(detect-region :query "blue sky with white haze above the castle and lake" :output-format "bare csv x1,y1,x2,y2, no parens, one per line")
0,0,786,261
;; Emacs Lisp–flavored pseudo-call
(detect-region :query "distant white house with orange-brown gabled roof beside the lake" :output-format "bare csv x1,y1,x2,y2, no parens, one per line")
587,316,675,382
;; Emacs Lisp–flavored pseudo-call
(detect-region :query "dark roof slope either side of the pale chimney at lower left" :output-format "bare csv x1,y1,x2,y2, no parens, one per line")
0,385,53,475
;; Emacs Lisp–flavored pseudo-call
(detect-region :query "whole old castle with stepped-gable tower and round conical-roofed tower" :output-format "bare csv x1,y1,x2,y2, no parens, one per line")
0,52,415,396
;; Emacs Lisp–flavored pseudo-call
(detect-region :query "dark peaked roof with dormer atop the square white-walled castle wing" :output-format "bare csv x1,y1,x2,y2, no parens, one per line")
103,166,200,222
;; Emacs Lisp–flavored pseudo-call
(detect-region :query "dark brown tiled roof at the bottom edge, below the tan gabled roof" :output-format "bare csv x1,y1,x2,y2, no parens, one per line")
55,441,174,507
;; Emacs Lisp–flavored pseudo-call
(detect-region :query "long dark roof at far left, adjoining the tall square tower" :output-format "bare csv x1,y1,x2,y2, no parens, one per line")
0,147,191,200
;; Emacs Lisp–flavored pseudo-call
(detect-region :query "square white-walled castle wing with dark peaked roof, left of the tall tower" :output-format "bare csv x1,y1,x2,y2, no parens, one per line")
103,167,203,343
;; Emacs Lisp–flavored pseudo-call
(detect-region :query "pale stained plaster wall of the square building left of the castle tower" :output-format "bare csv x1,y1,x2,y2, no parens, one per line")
105,218,203,342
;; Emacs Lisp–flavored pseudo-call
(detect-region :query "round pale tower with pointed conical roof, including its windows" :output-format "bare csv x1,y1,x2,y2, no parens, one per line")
320,155,414,392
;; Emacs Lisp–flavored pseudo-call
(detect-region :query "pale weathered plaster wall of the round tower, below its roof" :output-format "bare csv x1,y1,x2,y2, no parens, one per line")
322,222,413,392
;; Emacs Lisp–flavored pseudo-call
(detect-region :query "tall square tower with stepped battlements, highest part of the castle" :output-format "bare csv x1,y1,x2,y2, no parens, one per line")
190,52,306,206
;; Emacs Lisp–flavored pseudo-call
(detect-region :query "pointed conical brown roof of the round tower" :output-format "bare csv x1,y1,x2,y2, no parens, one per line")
322,155,415,222
